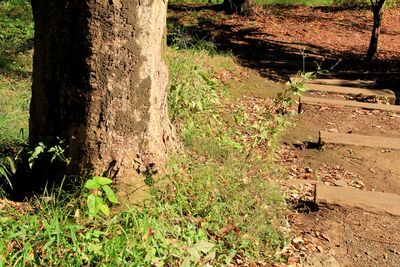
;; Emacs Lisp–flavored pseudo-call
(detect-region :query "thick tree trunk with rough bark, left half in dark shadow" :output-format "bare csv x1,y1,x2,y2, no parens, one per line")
29,0,174,182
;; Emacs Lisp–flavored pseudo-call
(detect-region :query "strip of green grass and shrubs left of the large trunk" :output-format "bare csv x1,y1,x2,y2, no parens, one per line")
0,0,33,146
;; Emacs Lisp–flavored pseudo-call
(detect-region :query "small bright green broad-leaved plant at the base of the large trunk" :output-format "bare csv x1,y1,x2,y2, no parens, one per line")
84,176,119,219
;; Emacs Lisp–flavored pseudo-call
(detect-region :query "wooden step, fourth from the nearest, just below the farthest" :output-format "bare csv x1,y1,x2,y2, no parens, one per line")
306,83,396,104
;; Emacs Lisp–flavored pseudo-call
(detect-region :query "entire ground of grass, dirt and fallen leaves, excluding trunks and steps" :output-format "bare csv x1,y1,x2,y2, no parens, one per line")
0,2,400,267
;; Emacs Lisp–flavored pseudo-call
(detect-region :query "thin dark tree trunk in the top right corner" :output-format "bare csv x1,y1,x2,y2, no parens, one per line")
367,0,386,61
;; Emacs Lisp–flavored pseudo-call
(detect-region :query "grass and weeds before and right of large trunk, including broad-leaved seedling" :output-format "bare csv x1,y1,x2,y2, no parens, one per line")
0,47,287,266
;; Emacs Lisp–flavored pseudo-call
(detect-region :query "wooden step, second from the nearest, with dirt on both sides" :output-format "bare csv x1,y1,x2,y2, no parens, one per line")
318,131,400,149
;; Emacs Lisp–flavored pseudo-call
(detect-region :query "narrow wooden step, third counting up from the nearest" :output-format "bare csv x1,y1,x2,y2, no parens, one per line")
301,96,400,112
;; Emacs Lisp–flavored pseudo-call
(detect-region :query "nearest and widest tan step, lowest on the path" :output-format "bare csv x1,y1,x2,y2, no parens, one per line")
314,184,400,216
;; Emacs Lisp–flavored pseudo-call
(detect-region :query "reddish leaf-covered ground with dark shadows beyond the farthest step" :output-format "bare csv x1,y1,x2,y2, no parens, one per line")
169,6,400,92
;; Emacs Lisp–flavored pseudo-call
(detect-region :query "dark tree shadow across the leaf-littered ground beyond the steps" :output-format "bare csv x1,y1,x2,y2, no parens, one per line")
168,6,400,100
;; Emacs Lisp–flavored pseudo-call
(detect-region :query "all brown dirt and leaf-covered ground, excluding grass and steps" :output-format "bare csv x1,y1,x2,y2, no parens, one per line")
170,4,400,266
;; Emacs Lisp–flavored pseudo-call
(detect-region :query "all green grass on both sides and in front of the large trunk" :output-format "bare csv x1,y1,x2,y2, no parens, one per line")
0,0,288,266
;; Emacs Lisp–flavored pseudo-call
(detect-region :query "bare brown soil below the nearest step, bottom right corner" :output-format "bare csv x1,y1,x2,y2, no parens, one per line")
291,207,400,266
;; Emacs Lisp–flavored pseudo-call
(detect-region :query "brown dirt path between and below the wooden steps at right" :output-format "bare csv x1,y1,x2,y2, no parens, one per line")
280,80,400,266
